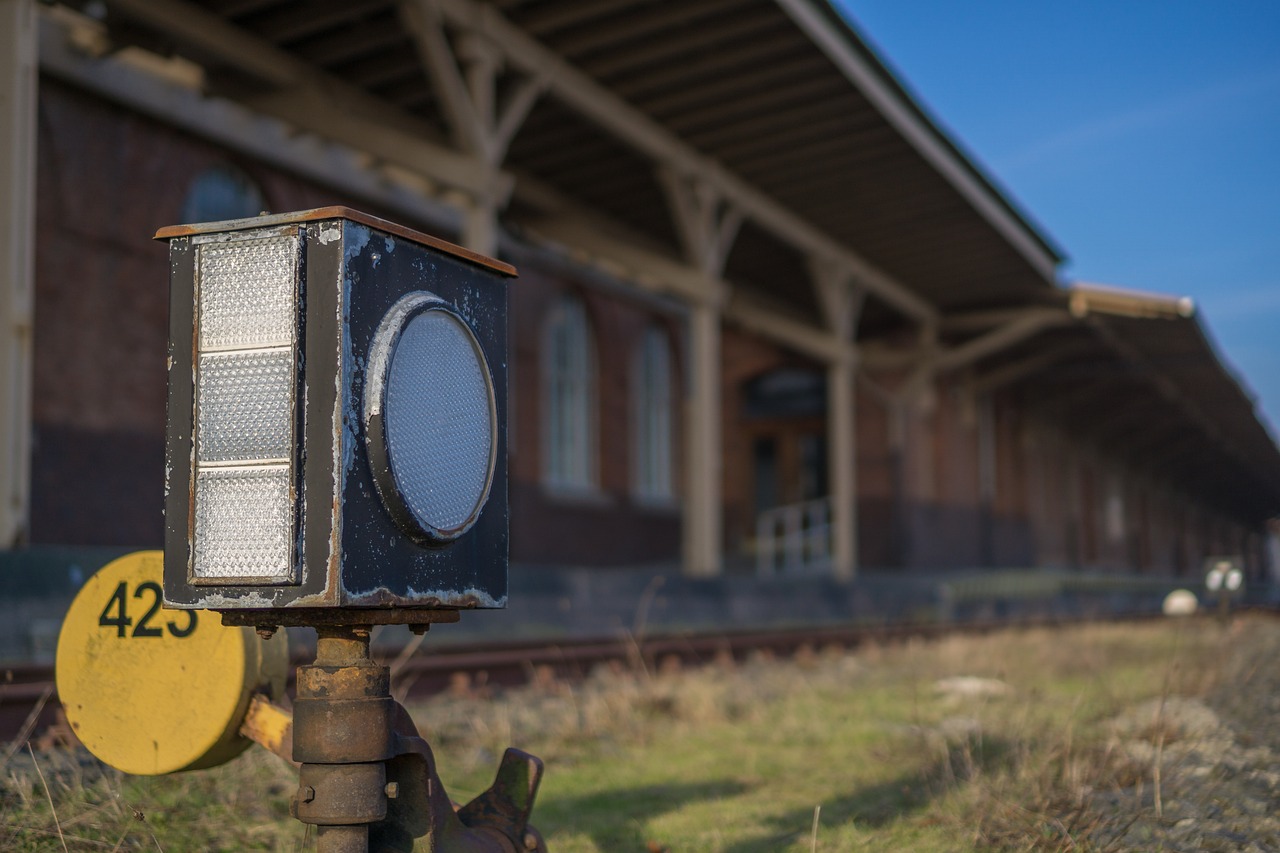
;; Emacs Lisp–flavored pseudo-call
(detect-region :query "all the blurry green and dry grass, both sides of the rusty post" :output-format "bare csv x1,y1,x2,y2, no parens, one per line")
0,621,1221,853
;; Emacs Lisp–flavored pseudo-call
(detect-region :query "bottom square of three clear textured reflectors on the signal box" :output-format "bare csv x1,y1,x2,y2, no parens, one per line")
192,465,293,581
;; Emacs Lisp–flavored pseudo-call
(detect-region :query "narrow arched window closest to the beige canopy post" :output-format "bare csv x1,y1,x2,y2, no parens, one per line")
632,327,675,501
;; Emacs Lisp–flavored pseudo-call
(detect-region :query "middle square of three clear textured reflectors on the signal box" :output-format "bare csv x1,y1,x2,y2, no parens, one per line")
196,348,293,462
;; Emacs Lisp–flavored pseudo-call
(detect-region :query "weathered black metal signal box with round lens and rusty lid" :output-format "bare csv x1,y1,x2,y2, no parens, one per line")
156,207,515,625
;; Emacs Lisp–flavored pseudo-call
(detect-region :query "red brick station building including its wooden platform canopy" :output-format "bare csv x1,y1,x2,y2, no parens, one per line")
0,0,1280,579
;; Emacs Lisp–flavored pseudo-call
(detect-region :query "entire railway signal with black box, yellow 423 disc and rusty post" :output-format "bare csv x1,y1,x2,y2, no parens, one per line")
58,207,547,852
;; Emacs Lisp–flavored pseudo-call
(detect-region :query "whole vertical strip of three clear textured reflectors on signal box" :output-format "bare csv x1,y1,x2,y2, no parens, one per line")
191,229,300,584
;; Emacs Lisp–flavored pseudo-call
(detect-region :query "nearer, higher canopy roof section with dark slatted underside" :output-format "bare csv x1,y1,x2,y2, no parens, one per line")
86,0,1061,321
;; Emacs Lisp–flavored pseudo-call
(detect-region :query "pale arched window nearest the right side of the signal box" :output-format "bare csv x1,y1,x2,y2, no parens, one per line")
543,296,595,489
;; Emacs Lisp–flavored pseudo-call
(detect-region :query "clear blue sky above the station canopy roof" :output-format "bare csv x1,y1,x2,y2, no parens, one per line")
837,0,1280,427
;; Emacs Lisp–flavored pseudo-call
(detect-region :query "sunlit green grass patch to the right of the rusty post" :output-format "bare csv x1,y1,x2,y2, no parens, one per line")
419,614,1219,853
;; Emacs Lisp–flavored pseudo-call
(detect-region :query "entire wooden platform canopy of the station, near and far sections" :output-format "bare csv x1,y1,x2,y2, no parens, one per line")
41,0,1280,519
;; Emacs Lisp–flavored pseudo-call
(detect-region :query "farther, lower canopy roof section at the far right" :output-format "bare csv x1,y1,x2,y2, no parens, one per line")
977,284,1280,524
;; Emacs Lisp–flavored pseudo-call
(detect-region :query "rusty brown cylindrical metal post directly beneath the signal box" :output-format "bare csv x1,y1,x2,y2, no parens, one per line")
292,626,396,853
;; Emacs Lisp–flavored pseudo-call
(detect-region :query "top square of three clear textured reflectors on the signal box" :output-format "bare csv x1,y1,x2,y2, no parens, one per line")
198,234,298,352
